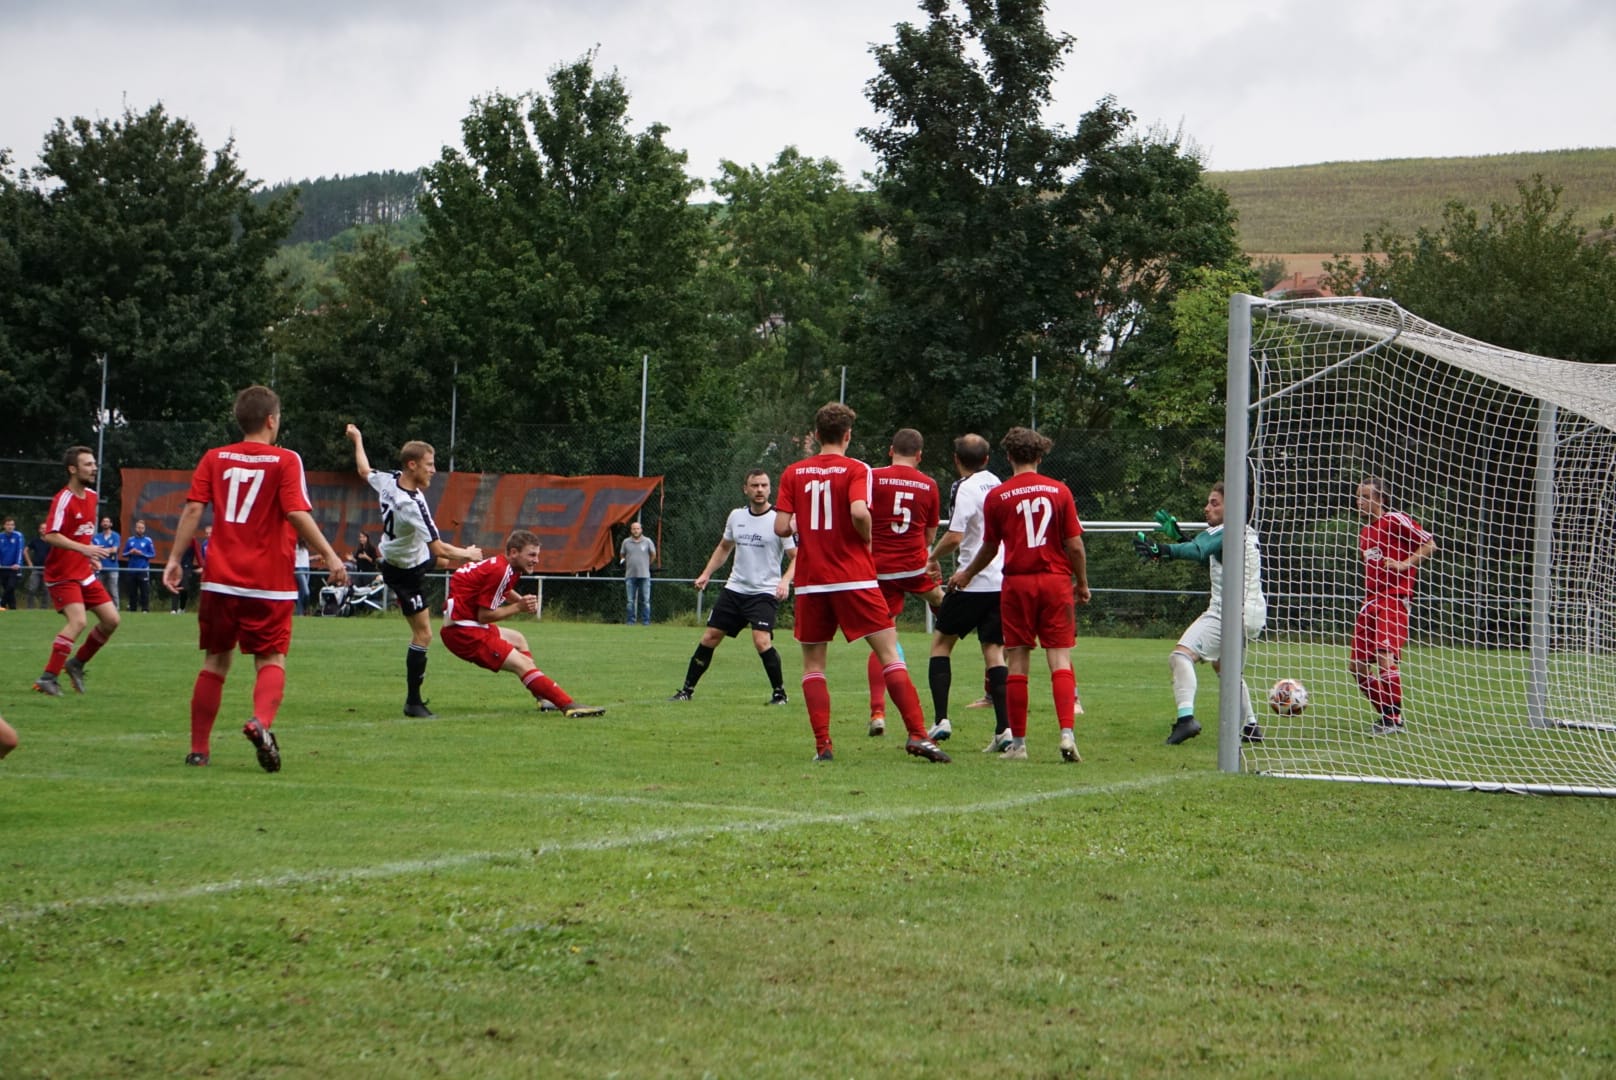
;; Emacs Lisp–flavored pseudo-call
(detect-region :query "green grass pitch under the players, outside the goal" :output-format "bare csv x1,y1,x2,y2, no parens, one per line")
0,613,1616,1080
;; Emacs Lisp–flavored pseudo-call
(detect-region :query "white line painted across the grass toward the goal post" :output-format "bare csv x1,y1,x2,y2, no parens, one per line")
0,773,1201,926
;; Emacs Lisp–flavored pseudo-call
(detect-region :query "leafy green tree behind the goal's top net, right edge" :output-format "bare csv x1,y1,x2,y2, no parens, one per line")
1325,175,1616,362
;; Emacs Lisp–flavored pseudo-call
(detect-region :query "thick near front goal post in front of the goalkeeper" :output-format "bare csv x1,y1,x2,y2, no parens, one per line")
1217,293,1254,773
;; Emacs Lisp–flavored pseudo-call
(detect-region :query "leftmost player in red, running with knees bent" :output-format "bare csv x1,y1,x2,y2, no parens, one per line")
34,446,118,697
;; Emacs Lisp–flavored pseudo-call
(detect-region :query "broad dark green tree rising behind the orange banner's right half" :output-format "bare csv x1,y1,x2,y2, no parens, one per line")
419,55,727,467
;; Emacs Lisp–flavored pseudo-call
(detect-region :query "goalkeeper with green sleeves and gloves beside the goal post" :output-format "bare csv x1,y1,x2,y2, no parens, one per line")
1133,480,1269,747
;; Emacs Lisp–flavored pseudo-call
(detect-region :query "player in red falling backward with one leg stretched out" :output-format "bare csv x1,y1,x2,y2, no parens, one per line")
438,529,606,718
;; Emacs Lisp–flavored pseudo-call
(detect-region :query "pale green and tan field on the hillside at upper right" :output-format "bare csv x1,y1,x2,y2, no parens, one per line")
1206,147,1616,254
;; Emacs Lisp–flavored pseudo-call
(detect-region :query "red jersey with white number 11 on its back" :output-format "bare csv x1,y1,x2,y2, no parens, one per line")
774,454,879,595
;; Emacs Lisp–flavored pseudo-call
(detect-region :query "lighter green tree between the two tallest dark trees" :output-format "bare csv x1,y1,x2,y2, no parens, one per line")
705,147,871,432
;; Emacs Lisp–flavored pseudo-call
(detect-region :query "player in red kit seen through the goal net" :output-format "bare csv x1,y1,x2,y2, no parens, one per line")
1351,477,1437,736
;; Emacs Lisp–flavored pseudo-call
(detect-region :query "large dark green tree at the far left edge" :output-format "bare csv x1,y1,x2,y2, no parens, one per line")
0,105,294,464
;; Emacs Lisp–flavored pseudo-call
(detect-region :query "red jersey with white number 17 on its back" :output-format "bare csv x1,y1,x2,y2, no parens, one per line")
186,443,310,600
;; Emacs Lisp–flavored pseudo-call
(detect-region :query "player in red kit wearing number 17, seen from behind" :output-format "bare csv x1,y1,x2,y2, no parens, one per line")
163,386,347,773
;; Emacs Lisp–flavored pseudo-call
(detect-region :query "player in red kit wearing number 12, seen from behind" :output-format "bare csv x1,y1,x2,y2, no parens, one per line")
949,427,1089,761
